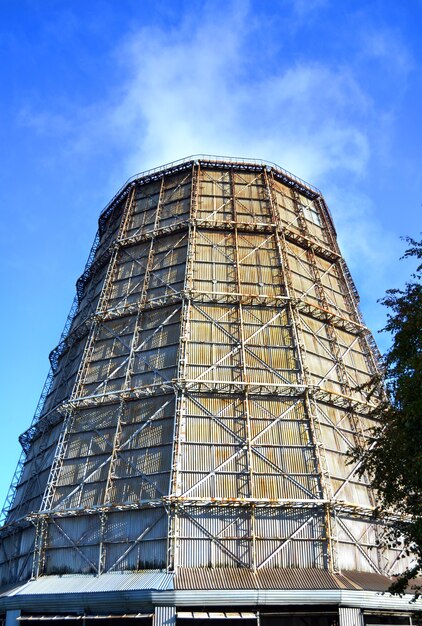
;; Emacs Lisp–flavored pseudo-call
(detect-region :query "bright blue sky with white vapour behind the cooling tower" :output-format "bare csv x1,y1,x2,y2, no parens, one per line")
0,0,422,500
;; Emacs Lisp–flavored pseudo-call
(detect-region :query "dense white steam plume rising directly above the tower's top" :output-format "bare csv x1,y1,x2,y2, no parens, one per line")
107,5,369,179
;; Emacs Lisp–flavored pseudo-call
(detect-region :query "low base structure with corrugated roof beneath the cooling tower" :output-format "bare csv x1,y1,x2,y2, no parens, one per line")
0,570,421,626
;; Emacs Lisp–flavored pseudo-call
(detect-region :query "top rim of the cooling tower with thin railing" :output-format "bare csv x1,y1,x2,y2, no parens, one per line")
100,154,322,224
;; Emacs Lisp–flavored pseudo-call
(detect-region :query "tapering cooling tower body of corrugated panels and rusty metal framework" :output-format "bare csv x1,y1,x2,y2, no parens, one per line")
0,158,410,584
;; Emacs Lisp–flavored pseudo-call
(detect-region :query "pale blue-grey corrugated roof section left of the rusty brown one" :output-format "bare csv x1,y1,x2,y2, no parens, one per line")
7,570,173,596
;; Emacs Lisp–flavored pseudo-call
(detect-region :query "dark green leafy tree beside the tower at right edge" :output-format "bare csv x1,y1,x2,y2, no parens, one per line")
354,237,422,595
